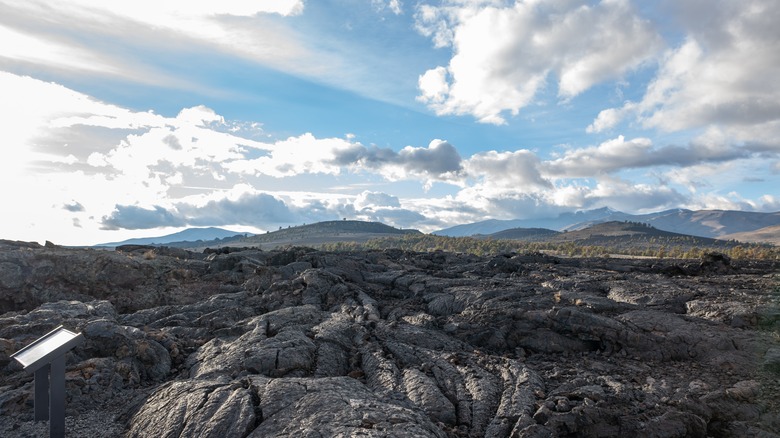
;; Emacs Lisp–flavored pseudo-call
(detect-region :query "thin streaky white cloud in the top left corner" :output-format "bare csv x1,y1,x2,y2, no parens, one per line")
0,0,310,88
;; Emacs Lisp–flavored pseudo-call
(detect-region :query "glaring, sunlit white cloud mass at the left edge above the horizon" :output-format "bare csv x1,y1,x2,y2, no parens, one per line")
0,72,280,243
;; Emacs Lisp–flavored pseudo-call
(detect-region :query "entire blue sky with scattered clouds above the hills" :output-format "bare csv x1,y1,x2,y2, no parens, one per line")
0,0,780,245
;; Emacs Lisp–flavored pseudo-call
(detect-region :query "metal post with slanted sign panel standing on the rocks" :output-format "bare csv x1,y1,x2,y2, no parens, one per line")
11,326,84,438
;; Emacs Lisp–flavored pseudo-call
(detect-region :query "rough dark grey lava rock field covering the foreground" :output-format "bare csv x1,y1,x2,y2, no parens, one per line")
0,242,780,437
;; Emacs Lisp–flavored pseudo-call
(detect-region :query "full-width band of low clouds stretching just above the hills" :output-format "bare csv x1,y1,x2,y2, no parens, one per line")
0,73,778,244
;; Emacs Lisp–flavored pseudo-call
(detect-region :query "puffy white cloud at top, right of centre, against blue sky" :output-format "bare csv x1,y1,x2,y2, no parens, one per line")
416,0,661,124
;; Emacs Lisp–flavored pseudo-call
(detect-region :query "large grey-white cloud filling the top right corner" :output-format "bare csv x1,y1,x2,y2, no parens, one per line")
588,0,780,147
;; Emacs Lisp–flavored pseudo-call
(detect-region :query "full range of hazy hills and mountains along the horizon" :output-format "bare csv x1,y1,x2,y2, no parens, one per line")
96,207,780,248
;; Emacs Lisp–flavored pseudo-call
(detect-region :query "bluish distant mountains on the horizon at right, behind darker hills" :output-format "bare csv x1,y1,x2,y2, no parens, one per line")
434,208,780,243
